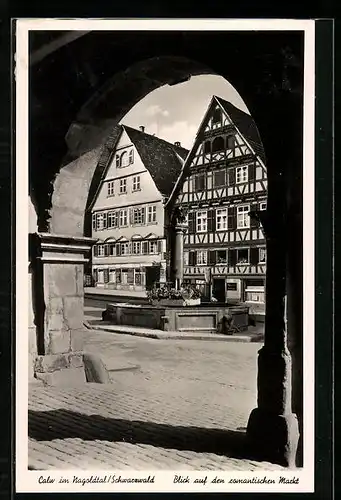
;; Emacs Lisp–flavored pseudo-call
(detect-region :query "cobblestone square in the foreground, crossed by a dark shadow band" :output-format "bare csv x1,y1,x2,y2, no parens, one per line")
29,318,280,470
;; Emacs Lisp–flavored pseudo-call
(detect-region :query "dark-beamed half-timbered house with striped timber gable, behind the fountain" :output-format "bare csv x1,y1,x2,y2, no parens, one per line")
169,96,267,309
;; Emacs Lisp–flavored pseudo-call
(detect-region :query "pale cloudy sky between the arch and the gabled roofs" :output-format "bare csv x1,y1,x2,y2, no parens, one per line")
121,75,249,149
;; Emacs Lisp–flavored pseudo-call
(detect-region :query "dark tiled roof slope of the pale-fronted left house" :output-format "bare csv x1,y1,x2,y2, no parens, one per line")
123,125,188,196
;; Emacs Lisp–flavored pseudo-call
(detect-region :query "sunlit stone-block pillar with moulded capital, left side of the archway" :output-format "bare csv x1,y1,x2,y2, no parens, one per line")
30,233,95,382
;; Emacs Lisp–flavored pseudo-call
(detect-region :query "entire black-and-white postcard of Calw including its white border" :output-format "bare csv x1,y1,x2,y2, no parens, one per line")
15,19,315,492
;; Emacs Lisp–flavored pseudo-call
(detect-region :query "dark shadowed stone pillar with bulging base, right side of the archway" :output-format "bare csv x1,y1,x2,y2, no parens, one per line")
247,209,299,467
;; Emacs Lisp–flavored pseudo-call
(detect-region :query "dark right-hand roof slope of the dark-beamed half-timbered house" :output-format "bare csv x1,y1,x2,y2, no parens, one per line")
213,96,265,163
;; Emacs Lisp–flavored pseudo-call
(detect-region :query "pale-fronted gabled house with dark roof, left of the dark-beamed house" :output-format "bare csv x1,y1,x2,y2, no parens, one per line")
90,125,188,291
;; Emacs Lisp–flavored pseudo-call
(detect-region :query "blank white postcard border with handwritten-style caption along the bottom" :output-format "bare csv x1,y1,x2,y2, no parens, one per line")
15,19,315,493
